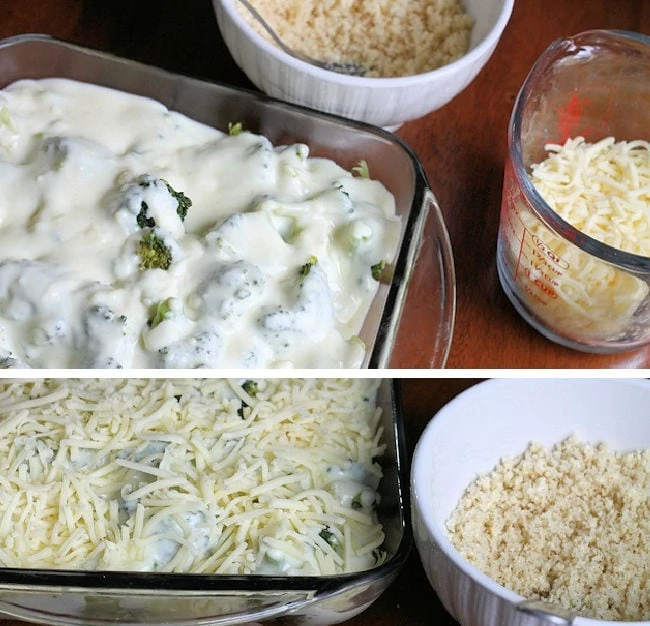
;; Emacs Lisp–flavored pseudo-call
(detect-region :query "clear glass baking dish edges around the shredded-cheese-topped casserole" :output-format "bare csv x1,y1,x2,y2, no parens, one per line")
0,379,413,626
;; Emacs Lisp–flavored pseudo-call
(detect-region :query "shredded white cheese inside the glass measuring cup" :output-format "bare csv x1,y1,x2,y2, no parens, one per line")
522,137,650,339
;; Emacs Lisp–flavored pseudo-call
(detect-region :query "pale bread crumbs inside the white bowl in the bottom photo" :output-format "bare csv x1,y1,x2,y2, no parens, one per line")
447,437,650,621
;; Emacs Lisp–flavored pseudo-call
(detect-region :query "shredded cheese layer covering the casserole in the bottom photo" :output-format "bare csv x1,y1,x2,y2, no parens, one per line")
0,379,384,575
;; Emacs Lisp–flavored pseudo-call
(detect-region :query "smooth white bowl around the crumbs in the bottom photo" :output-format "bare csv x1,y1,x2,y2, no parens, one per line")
411,378,650,626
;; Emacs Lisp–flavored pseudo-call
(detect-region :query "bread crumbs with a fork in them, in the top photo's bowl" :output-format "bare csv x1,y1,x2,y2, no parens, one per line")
237,0,474,78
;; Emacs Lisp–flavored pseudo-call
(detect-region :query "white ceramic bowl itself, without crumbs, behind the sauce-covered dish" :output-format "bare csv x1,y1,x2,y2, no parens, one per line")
213,0,514,129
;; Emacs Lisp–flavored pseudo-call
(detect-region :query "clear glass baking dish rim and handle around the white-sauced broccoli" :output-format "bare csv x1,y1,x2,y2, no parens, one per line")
0,34,455,368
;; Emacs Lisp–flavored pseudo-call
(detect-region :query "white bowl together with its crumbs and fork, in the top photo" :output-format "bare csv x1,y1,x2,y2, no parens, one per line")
212,0,514,131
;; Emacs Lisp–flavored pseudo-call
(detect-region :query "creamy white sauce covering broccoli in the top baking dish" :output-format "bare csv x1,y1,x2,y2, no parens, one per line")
0,79,401,368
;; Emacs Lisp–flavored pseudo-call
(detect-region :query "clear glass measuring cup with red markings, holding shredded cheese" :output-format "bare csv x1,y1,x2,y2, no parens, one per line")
497,30,650,353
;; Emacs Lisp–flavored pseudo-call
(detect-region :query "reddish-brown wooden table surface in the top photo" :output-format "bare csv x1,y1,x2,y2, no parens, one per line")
0,0,650,368
